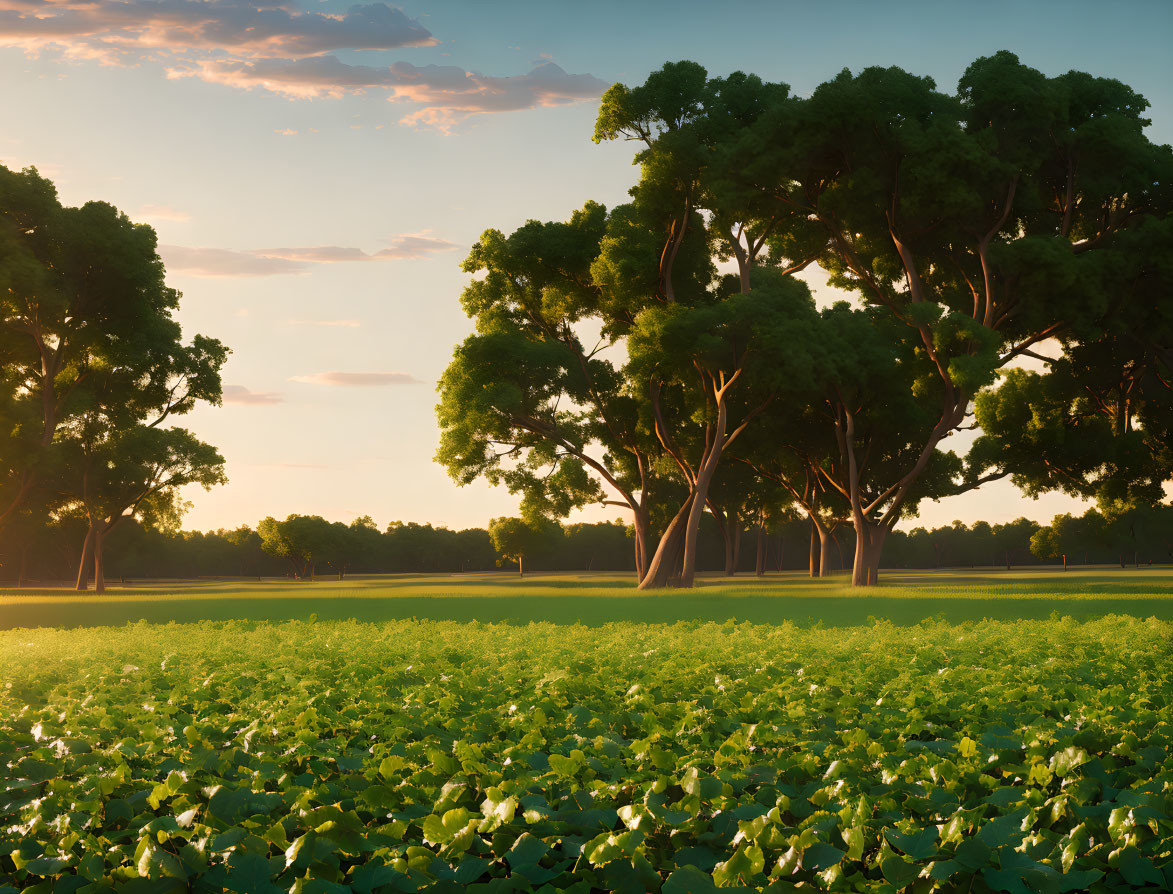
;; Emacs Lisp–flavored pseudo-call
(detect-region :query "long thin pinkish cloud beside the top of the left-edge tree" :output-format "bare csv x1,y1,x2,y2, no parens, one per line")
158,231,460,277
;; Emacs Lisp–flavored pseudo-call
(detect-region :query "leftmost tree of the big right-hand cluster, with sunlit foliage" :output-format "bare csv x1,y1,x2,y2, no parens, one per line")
436,203,670,576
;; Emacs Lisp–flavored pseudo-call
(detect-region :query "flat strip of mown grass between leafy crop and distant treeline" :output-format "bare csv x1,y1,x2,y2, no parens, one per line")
0,565,1173,629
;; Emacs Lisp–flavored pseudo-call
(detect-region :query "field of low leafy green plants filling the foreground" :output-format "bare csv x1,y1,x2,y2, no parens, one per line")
0,617,1173,894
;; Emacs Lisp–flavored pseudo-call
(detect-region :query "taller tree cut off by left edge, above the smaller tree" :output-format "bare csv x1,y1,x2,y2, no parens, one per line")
0,167,226,524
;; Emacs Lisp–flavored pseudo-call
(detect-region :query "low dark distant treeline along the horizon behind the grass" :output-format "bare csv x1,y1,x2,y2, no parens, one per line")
0,507,1173,585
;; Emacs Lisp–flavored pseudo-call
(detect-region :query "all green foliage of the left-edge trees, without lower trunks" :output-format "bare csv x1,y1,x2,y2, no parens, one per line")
0,165,228,529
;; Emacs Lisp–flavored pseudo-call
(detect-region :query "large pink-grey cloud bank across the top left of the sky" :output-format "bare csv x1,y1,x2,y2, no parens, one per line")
0,0,608,133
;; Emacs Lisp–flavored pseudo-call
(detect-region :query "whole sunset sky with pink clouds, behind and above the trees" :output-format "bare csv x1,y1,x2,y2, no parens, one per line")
0,0,1173,529
